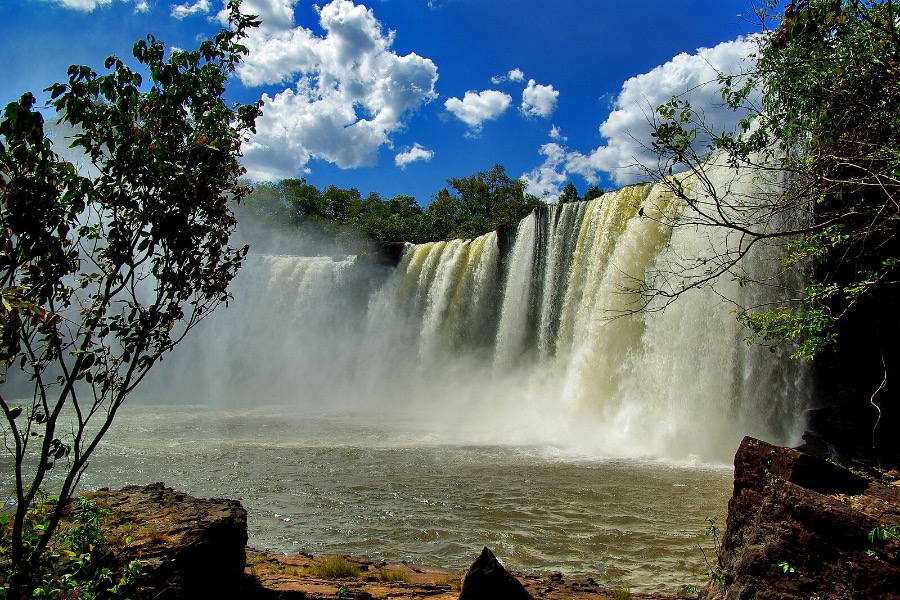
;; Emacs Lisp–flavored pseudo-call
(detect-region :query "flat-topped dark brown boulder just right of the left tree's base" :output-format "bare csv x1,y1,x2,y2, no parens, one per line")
91,483,247,600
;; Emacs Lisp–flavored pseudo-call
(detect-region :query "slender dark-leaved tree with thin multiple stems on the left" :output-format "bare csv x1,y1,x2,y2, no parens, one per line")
0,0,260,598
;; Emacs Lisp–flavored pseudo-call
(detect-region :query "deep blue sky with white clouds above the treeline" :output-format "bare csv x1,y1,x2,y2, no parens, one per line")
0,0,772,205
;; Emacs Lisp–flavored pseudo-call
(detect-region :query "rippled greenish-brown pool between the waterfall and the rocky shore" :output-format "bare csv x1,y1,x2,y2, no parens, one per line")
83,405,731,591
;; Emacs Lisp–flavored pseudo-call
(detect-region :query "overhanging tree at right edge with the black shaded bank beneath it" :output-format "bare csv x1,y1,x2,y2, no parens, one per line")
643,0,900,464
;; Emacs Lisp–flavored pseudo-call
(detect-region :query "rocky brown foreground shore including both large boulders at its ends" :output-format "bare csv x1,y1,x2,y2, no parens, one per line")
49,437,900,600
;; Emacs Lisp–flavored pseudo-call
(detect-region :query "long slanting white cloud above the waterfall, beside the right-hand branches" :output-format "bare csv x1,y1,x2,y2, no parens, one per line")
565,38,757,185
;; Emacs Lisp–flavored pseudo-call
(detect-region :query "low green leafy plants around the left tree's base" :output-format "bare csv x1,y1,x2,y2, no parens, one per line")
0,493,143,600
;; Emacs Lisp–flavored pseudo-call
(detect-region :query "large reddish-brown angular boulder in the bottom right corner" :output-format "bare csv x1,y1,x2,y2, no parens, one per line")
701,438,900,600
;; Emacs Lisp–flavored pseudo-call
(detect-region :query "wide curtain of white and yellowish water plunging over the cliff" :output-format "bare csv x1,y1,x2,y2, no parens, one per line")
151,166,808,462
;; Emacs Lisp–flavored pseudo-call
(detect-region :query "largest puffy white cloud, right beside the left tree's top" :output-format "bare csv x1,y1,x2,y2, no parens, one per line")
237,0,438,179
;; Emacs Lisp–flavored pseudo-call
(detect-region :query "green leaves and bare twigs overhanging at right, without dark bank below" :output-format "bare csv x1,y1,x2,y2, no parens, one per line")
648,0,900,357
